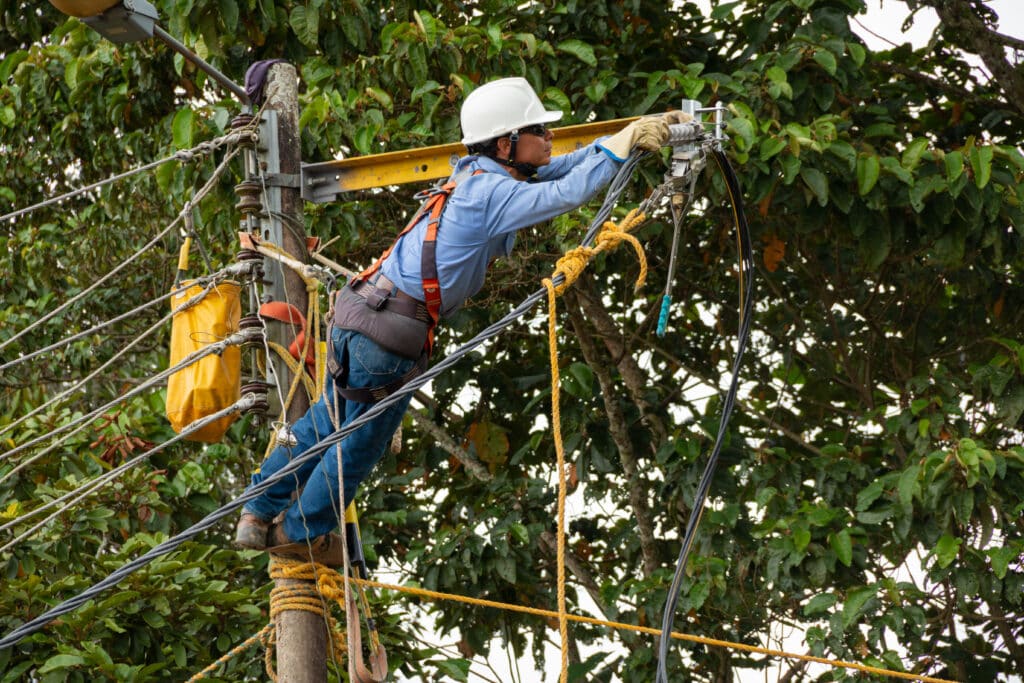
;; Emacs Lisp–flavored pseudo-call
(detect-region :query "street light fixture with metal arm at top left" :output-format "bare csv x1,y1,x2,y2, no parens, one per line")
50,0,250,104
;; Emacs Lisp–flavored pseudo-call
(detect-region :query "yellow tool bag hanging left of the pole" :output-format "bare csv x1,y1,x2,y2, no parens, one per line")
167,281,242,443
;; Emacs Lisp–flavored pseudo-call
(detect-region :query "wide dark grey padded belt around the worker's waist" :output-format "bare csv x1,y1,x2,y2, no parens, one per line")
328,275,432,403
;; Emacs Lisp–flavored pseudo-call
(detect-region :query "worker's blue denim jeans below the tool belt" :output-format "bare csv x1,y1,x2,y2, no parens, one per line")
245,328,416,542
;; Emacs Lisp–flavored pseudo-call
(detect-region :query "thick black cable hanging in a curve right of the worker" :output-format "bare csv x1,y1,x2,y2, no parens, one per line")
655,150,754,683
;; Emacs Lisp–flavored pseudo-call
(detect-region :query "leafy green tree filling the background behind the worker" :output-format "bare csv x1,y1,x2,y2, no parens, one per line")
0,0,1024,681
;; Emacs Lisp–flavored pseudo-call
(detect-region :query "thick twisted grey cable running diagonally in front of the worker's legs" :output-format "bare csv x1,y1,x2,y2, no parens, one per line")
0,145,642,650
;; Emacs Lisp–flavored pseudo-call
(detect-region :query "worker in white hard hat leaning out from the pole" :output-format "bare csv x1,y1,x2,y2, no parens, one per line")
236,78,689,561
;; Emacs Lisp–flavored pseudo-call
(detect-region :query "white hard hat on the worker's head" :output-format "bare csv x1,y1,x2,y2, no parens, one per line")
461,78,562,145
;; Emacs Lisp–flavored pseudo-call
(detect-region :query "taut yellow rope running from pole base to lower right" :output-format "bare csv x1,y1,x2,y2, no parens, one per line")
349,578,956,683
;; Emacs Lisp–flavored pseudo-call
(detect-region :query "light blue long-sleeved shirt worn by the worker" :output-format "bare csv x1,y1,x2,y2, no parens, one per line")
381,144,620,315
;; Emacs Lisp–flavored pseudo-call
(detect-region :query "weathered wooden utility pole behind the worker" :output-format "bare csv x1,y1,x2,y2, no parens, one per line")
259,63,328,683
